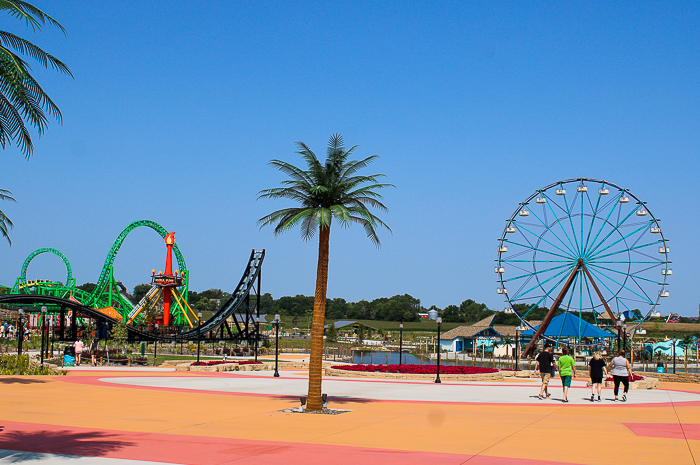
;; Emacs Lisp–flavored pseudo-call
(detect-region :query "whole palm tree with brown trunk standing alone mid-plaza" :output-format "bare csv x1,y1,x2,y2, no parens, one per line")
258,134,393,411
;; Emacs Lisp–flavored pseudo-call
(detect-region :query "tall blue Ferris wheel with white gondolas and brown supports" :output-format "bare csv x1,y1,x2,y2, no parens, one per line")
494,178,673,350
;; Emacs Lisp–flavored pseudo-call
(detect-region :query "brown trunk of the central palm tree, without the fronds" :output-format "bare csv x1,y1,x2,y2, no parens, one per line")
306,226,331,412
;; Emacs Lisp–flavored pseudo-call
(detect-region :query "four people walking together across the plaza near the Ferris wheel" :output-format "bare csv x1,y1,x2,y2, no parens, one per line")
535,344,634,402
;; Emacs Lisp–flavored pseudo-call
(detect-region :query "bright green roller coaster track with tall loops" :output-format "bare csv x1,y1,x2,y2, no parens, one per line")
10,220,189,324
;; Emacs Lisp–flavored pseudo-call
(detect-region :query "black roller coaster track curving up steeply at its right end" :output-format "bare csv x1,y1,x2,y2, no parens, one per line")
0,249,265,342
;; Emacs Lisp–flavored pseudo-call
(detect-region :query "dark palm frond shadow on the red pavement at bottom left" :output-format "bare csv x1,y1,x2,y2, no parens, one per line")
0,426,134,463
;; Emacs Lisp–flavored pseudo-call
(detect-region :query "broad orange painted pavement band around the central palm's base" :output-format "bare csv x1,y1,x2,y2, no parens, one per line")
0,371,700,464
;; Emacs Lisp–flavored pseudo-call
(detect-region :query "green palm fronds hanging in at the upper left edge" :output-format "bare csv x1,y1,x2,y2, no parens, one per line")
0,0,73,243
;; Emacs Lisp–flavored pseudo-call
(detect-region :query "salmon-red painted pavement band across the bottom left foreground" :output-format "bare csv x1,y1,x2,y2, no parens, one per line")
0,421,584,465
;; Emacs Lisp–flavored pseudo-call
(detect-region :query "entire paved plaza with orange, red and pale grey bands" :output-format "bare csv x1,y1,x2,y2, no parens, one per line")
0,367,700,465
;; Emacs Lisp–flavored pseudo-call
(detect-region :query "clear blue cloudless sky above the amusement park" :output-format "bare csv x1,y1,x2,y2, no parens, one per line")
0,0,700,315
